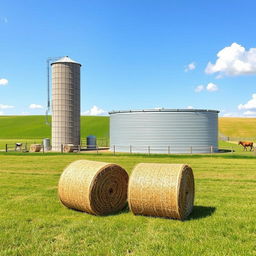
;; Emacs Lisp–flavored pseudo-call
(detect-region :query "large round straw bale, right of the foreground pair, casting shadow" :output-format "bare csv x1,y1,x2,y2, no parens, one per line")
128,163,195,220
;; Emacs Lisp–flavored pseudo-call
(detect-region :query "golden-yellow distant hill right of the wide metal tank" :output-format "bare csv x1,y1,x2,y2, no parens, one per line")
219,117,256,138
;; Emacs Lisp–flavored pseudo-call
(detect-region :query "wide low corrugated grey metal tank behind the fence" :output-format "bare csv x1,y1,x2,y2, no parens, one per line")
109,109,219,153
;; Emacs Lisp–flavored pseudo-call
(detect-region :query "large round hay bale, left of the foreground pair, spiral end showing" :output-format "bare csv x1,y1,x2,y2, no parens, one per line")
58,160,128,215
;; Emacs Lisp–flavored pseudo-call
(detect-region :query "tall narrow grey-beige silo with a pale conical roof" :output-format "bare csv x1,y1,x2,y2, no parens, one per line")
51,56,81,151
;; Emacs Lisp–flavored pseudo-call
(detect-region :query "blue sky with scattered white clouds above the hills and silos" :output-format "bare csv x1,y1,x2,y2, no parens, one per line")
0,0,256,117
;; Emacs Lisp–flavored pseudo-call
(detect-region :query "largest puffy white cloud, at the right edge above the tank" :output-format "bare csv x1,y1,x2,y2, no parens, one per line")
205,43,256,77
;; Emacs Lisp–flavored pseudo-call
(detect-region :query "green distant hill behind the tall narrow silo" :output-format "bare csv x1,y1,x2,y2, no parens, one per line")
0,116,109,139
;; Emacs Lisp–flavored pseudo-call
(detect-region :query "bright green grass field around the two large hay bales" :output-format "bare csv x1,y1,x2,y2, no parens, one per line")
0,153,256,256
